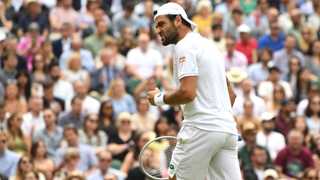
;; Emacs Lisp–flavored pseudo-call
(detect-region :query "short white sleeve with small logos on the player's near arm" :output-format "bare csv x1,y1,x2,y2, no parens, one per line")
176,48,199,79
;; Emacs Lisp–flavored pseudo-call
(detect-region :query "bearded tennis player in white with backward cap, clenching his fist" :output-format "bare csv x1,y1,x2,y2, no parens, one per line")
148,3,241,180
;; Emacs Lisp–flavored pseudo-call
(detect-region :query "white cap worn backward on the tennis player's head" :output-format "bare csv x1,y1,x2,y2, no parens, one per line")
154,2,197,30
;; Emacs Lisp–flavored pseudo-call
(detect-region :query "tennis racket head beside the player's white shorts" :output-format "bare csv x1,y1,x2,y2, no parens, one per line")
139,136,177,180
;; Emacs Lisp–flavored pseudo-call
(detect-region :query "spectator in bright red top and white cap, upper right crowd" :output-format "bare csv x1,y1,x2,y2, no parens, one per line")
236,24,258,64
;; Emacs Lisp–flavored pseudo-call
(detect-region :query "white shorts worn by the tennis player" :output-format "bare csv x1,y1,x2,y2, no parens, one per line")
169,125,241,180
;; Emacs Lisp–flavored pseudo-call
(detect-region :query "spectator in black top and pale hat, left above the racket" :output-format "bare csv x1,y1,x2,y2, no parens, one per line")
108,112,135,162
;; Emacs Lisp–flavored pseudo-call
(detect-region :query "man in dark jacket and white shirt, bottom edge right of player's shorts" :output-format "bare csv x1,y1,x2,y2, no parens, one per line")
243,146,272,180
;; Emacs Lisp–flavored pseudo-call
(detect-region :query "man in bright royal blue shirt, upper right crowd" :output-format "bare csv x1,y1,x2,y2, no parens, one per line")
258,22,285,52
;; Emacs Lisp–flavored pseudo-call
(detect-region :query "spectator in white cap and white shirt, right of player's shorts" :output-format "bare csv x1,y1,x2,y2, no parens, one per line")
257,112,286,159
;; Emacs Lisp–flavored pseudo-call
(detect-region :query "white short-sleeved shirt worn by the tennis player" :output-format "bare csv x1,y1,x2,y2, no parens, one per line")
173,32,237,134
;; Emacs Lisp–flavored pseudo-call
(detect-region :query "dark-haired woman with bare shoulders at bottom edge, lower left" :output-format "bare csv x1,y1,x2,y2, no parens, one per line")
30,140,55,179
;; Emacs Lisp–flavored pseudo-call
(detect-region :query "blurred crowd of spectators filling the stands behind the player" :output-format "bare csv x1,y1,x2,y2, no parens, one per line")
0,0,320,180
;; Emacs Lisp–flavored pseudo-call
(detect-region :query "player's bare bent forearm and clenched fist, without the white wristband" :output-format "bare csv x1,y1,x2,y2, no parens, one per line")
148,76,198,105
